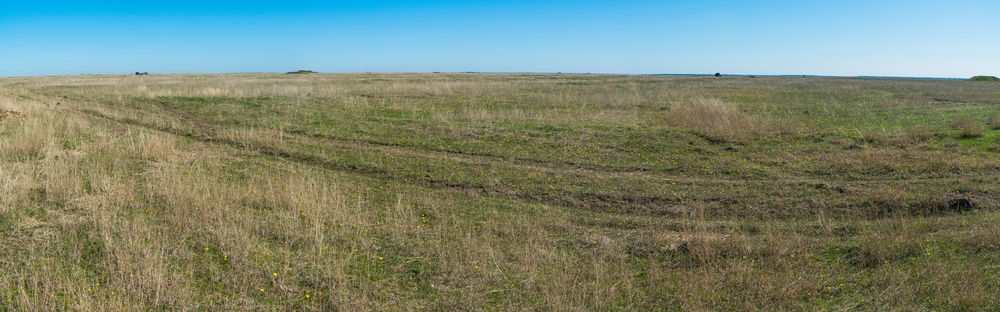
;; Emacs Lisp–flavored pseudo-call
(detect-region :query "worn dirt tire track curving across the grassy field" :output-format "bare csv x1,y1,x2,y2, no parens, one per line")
54,93,1000,217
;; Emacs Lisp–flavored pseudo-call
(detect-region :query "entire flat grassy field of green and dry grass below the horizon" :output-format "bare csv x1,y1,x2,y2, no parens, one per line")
0,74,1000,311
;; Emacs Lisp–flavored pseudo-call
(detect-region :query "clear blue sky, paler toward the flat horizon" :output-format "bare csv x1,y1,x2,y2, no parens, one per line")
0,0,1000,77
